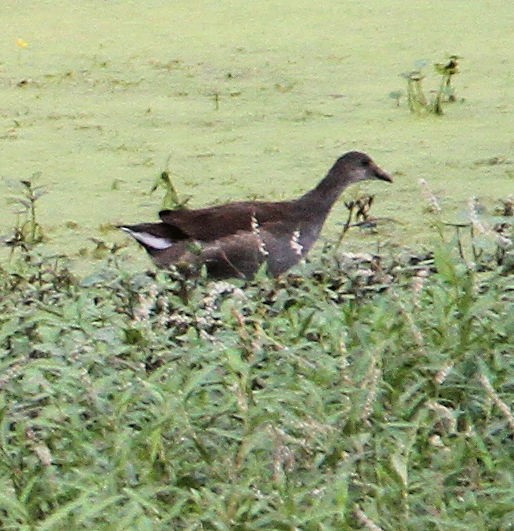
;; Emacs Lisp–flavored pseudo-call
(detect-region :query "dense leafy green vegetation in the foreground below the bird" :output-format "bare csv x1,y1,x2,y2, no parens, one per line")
0,222,514,530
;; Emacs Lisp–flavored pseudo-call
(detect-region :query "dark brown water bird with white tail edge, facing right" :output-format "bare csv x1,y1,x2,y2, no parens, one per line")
118,151,393,279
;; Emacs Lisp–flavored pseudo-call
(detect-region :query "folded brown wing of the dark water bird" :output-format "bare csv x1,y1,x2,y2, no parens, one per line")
159,201,294,241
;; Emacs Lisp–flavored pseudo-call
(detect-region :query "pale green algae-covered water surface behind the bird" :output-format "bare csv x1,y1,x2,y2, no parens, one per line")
0,0,514,270
